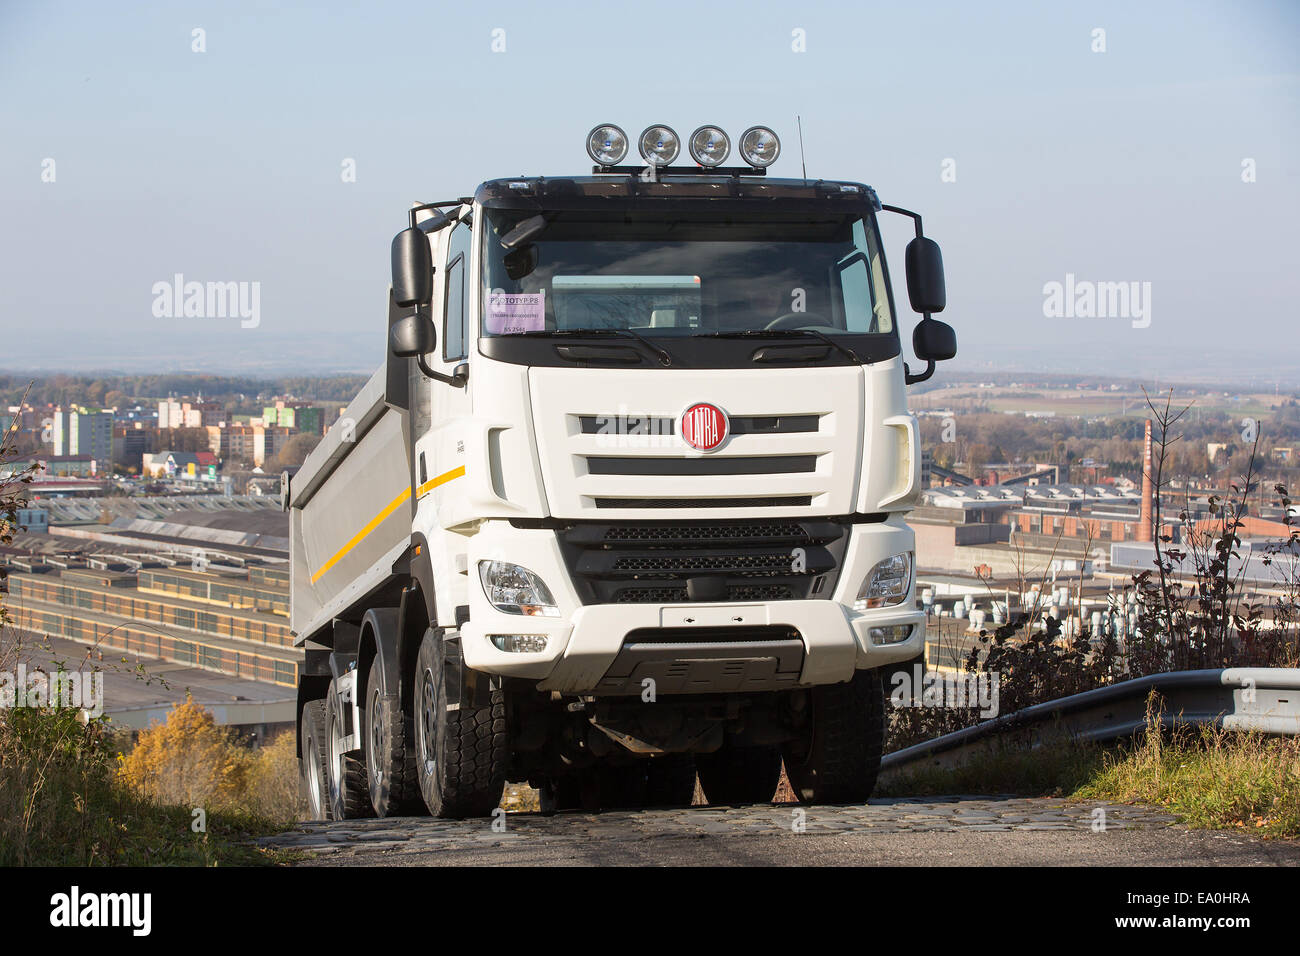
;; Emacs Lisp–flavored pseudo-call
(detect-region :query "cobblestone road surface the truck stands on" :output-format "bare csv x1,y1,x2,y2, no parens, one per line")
253,796,1300,866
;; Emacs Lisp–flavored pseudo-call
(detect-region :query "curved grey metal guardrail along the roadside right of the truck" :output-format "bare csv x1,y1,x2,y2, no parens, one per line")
880,667,1300,775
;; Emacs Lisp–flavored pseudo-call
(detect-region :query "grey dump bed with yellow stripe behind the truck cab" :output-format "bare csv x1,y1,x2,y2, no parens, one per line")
286,368,413,644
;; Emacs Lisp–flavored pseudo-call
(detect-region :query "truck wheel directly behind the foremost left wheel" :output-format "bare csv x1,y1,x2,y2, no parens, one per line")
365,656,425,817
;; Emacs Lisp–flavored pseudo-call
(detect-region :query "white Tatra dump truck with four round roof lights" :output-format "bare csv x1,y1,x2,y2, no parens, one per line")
292,125,956,819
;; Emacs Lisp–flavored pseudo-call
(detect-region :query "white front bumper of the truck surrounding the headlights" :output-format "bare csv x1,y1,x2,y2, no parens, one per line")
460,516,926,693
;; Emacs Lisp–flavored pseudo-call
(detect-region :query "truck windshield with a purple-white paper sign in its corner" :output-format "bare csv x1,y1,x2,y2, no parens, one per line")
480,209,894,346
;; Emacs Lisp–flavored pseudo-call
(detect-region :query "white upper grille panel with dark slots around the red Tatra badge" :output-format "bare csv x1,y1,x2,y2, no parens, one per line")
528,367,863,523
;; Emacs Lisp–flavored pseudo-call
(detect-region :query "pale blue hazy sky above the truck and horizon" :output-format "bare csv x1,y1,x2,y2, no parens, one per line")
0,0,1300,382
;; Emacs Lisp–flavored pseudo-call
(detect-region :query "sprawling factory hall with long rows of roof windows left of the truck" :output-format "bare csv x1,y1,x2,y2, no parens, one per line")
0,496,302,697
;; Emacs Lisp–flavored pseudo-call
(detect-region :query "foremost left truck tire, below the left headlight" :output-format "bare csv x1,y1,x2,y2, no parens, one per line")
415,628,510,819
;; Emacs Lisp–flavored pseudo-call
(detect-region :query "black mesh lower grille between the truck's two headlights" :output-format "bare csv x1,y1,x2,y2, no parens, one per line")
558,519,848,604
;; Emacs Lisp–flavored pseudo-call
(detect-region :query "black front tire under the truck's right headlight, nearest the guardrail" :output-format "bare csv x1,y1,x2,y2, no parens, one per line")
784,671,885,804
